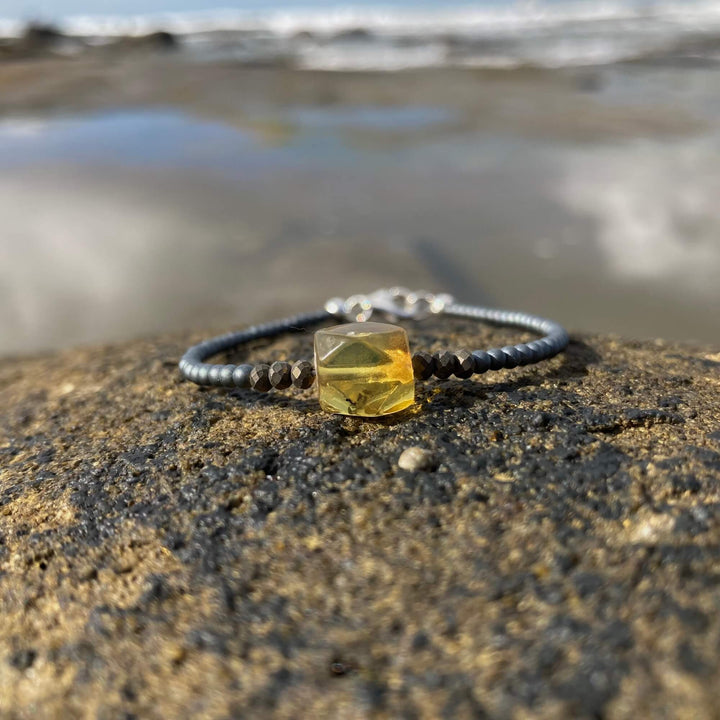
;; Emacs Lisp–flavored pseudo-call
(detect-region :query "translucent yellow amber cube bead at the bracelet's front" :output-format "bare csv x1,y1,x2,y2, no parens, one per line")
315,322,415,417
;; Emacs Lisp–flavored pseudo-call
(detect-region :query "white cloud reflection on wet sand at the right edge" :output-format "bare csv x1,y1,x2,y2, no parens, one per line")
558,138,720,288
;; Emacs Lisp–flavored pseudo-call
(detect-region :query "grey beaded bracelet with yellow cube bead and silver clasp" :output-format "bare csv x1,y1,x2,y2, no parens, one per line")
179,288,569,417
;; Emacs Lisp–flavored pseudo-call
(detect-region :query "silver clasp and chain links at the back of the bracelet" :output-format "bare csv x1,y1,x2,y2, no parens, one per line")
325,287,454,322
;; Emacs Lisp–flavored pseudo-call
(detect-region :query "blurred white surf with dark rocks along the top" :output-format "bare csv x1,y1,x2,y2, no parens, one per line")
0,0,720,70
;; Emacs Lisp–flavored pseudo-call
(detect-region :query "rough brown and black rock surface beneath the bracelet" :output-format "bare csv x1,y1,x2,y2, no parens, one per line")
0,323,720,719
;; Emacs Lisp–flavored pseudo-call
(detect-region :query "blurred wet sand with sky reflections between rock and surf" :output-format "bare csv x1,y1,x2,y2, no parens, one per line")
0,56,720,353
